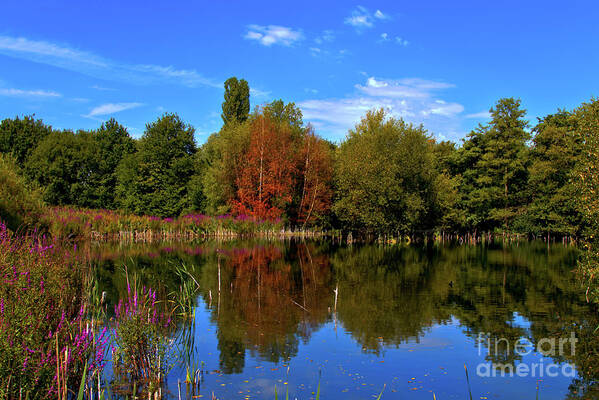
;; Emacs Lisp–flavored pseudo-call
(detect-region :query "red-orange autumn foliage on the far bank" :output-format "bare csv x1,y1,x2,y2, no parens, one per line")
231,113,332,226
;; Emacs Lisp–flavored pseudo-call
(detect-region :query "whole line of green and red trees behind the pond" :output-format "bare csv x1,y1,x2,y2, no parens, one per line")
0,78,599,237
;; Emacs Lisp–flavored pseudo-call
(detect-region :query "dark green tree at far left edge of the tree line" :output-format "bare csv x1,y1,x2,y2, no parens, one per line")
0,115,52,167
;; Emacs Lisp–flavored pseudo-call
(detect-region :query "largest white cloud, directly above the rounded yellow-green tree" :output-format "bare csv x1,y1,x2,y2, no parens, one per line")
299,77,464,138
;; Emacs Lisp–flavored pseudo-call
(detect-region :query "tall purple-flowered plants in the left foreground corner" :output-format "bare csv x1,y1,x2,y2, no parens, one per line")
0,221,108,398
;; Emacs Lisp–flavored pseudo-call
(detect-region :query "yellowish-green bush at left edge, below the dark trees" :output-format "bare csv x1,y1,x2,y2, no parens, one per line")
0,154,43,231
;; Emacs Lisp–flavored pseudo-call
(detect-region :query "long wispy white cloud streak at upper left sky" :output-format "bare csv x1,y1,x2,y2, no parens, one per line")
0,36,222,88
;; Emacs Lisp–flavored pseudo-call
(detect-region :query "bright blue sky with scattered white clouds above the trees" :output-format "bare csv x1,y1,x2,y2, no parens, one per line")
0,0,599,144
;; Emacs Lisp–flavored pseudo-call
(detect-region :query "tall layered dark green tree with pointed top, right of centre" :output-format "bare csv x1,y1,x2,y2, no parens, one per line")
457,98,530,231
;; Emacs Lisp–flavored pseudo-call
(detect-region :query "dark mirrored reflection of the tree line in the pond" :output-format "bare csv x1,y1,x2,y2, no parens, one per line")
86,242,599,398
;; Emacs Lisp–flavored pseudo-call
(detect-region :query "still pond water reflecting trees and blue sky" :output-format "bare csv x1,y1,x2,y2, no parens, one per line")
88,241,599,399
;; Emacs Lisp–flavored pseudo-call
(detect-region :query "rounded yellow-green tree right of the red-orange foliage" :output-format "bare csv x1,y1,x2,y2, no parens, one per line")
333,110,438,233
